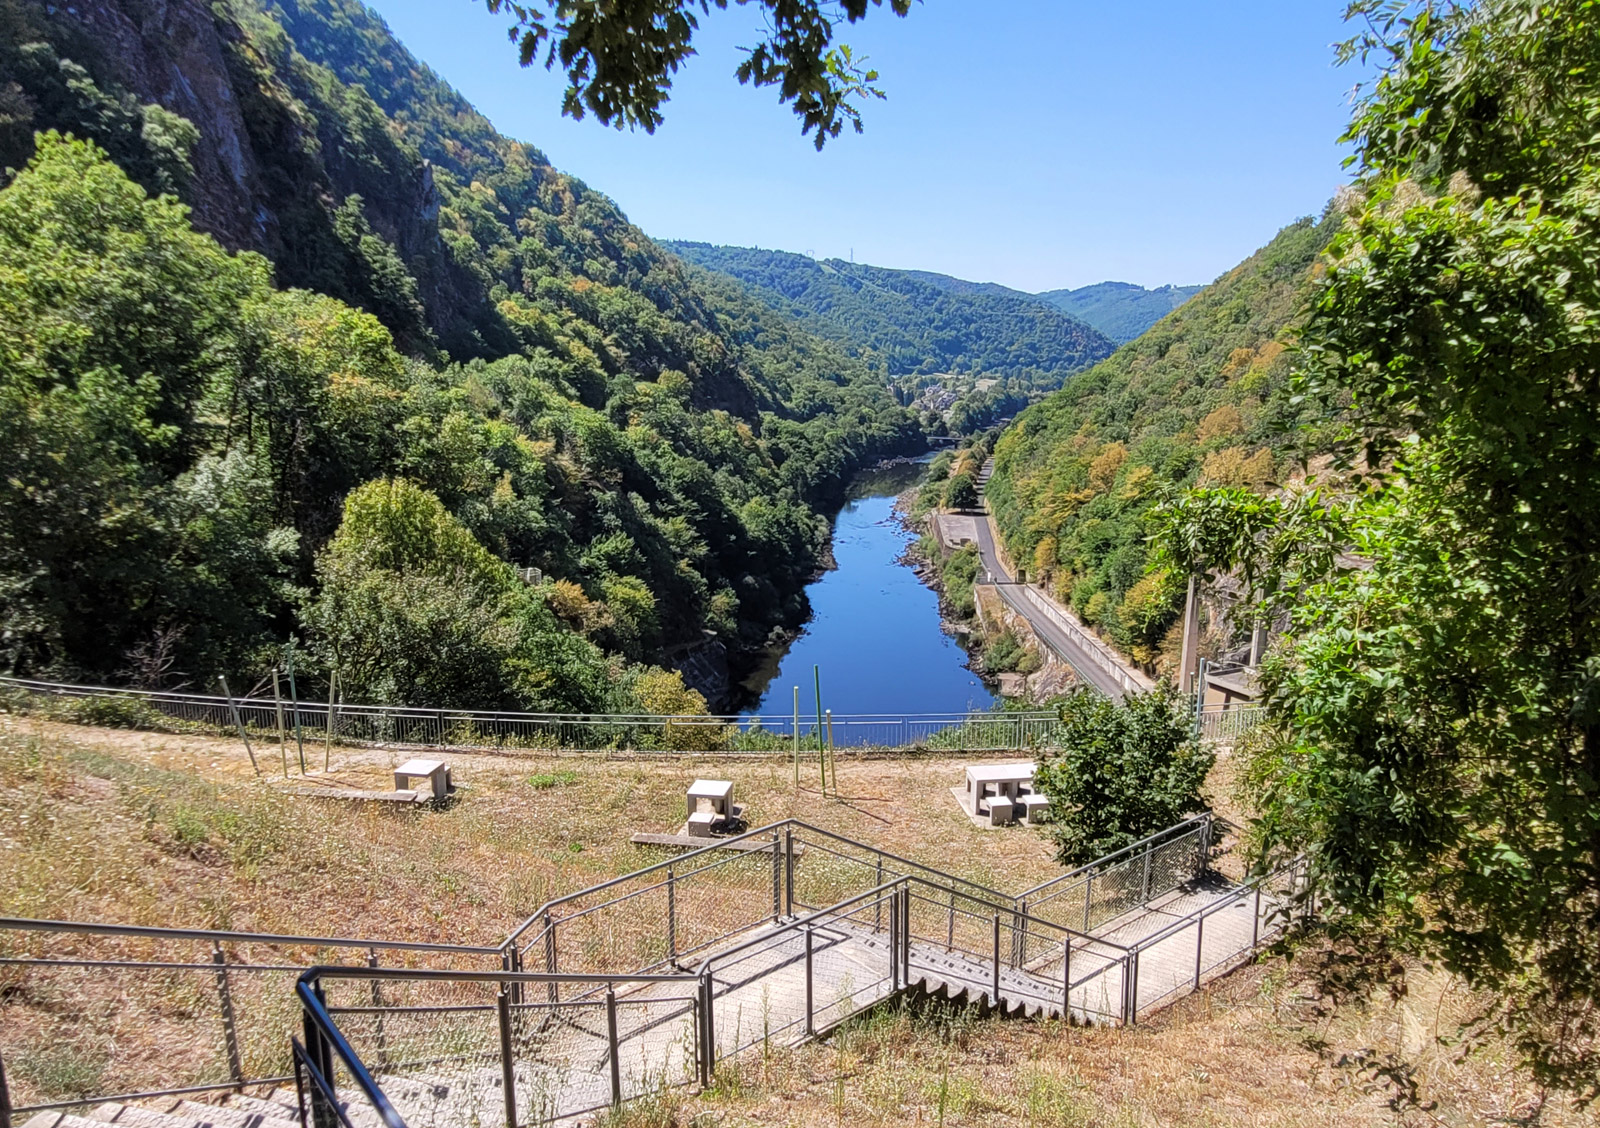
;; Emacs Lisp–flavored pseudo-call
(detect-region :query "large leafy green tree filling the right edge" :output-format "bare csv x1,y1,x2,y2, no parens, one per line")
1170,0,1600,1098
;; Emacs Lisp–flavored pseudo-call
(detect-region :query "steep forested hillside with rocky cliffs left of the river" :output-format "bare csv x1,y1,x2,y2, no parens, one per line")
0,0,923,709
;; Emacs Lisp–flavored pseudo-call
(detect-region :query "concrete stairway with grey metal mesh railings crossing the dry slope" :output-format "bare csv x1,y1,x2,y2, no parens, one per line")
0,816,1301,1128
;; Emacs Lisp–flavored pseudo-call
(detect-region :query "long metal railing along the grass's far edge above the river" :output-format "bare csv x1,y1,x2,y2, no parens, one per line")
0,677,1061,758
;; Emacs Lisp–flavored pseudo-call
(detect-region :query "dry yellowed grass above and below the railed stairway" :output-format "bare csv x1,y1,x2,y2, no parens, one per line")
0,717,1600,1128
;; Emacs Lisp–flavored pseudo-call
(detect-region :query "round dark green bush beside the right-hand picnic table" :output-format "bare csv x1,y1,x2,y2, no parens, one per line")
1034,690,1216,866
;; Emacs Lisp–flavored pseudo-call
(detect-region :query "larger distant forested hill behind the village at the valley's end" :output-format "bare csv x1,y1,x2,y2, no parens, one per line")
669,243,1114,430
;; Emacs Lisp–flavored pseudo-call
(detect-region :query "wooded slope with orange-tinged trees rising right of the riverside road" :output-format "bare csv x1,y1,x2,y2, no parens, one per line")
987,218,1338,664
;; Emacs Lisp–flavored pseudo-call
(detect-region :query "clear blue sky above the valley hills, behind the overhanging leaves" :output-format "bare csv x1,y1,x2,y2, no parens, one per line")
368,0,1357,290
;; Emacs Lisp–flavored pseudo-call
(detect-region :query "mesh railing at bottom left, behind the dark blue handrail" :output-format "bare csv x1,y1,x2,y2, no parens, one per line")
0,918,501,1114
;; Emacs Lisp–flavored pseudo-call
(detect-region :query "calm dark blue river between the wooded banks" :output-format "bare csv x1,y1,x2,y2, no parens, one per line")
746,466,994,718
